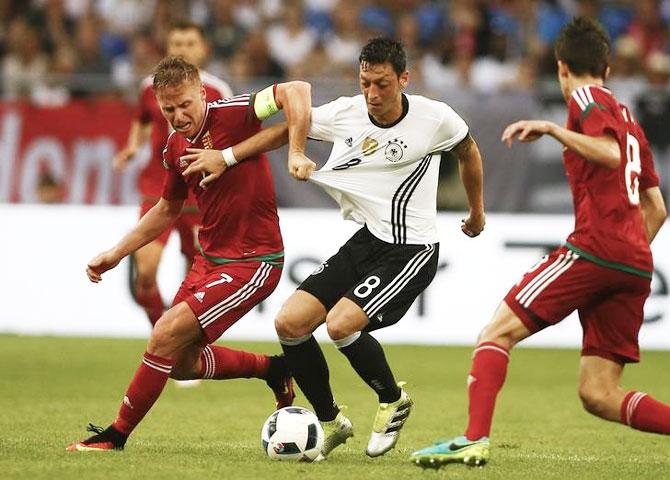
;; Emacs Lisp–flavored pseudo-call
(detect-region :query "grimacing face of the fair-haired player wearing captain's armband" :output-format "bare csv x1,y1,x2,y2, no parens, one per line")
156,82,206,138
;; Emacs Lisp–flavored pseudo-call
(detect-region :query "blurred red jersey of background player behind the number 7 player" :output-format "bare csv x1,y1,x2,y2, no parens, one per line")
137,71,233,201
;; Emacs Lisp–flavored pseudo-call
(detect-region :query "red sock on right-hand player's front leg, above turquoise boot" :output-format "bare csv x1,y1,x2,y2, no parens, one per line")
465,342,509,440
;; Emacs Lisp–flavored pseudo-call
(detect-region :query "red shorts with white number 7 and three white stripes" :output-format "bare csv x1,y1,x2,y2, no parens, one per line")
172,255,281,343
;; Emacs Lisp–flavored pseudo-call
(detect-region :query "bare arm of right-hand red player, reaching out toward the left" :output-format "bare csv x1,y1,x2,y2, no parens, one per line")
501,120,621,168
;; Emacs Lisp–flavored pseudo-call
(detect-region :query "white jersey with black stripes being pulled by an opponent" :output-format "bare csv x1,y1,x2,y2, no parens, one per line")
309,95,468,244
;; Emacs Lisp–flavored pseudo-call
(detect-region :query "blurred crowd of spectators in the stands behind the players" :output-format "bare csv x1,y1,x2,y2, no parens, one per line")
0,0,670,211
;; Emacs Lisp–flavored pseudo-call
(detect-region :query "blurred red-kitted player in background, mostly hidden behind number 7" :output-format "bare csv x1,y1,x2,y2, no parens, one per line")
114,21,233,325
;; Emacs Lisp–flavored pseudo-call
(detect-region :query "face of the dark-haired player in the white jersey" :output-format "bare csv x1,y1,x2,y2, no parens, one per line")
359,62,409,123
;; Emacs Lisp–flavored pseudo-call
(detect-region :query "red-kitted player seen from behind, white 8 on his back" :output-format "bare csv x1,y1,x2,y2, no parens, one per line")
411,18,670,467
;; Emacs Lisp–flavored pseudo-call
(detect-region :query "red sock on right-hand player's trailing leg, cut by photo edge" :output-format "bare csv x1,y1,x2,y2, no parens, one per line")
621,392,670,435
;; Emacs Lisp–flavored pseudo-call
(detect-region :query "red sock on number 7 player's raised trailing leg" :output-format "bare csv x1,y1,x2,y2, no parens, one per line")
200,345,270,380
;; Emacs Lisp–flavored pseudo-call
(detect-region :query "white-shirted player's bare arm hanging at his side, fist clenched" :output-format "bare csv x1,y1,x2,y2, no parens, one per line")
451,134,486,237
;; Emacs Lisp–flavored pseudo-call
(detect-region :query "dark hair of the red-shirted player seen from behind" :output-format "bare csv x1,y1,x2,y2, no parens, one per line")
554,17,610,79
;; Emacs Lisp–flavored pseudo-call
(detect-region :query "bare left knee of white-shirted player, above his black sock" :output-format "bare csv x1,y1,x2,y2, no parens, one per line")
275,290,326,339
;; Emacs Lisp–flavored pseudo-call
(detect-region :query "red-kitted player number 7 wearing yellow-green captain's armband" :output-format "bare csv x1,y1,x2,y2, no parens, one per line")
68,57,314,451
